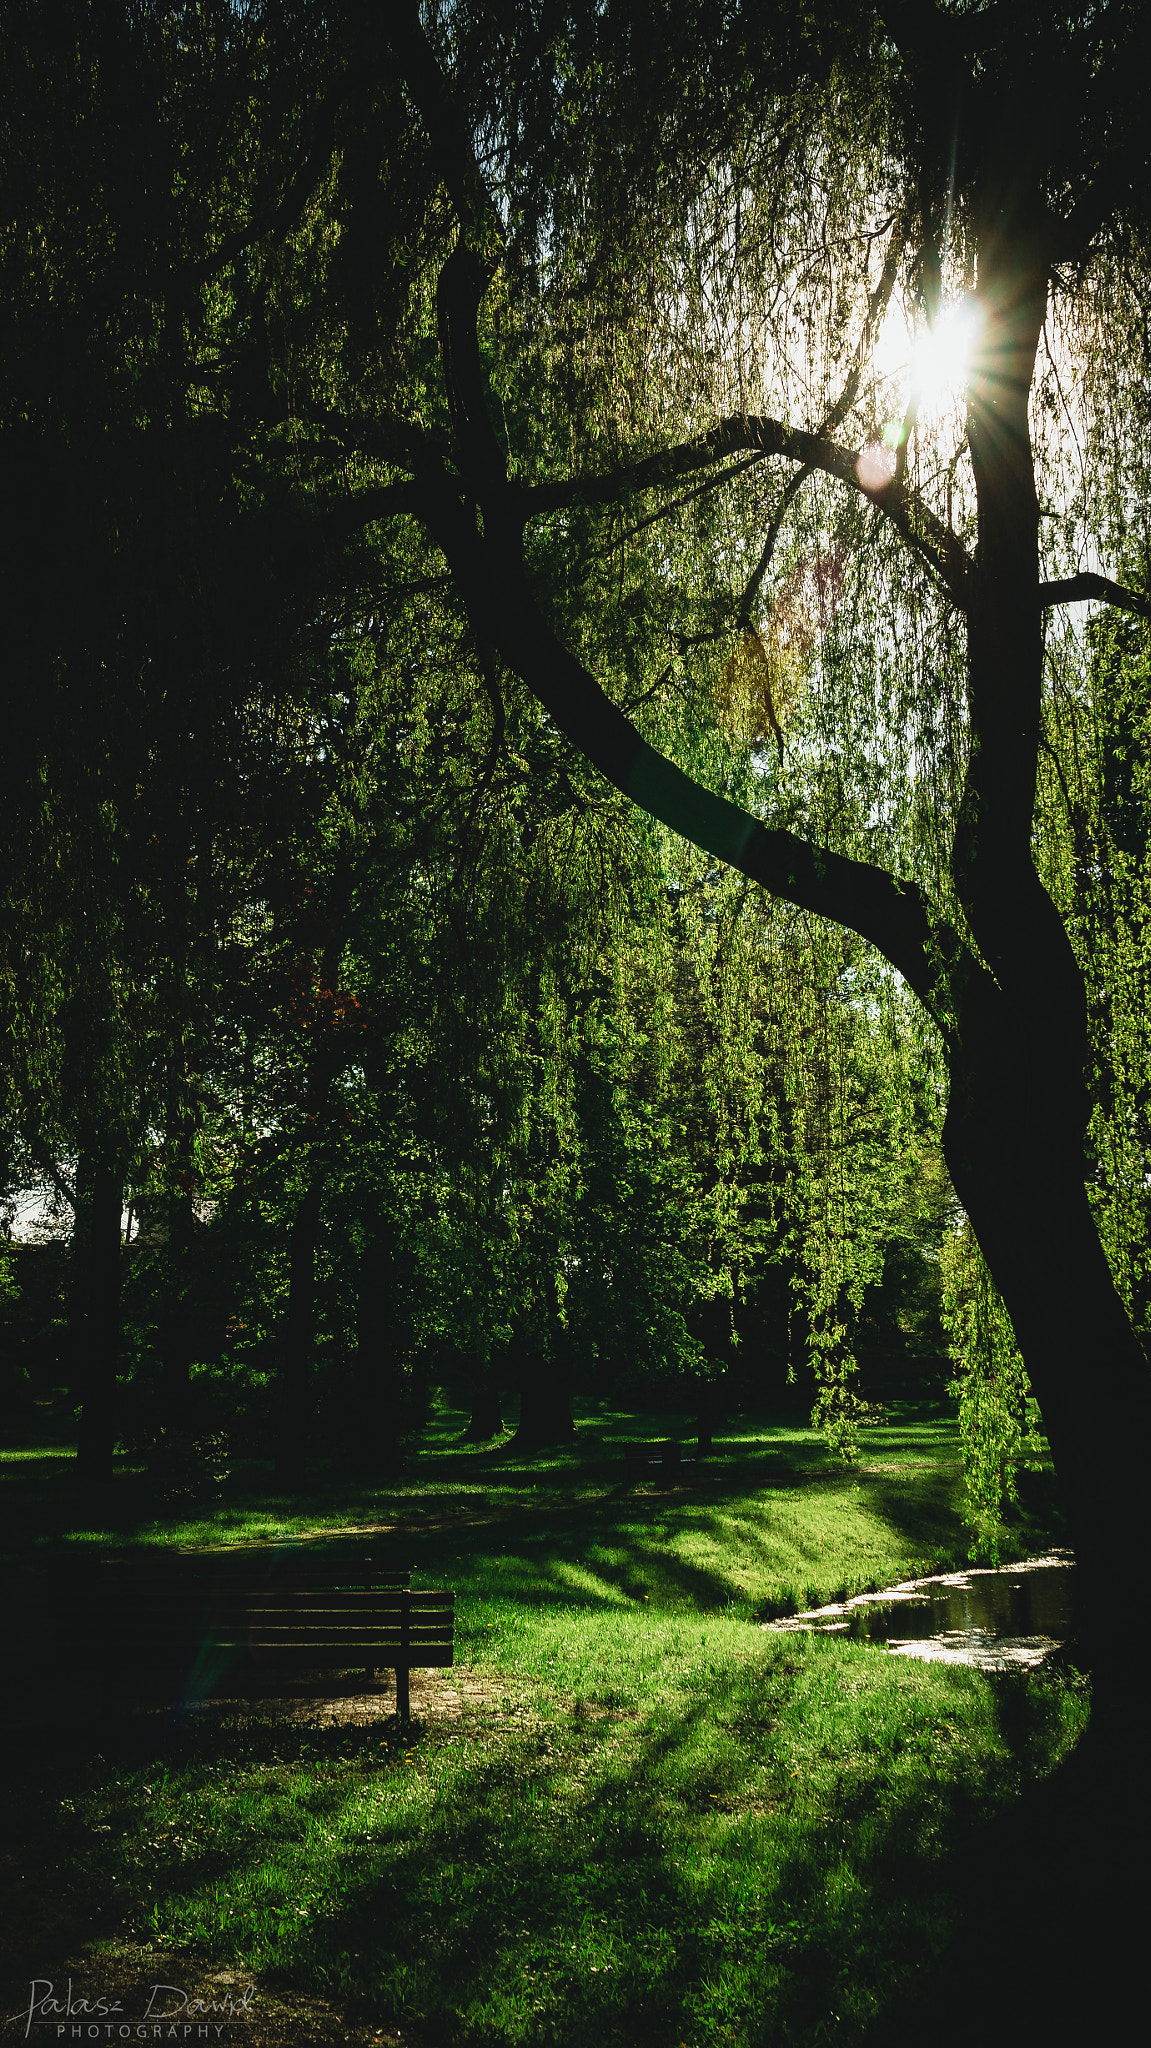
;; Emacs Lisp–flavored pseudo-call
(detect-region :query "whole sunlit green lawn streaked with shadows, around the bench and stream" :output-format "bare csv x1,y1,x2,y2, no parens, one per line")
0,1405,1088,2048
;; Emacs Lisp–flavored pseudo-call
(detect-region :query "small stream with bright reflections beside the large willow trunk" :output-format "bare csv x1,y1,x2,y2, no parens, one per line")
762,1550,1075,1671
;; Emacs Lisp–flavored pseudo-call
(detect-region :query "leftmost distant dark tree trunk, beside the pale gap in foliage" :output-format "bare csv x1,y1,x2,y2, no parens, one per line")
72,1153,123,1485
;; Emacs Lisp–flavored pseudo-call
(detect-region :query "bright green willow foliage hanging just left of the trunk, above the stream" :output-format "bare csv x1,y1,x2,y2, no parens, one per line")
940,1221,1040,1565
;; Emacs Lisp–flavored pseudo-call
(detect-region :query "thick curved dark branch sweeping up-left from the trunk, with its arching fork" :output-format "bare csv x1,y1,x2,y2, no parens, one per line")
380,8,983,1032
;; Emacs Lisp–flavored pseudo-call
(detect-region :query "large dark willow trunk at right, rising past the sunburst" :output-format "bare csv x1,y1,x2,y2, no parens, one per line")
944,207,1149,1692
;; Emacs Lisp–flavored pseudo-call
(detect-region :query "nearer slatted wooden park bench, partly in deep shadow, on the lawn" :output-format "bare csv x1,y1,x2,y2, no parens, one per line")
90,1552,455,1720
